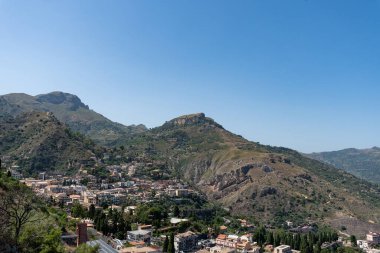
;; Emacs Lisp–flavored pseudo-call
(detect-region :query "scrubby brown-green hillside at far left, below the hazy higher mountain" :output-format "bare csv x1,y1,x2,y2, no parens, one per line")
0,112,100,175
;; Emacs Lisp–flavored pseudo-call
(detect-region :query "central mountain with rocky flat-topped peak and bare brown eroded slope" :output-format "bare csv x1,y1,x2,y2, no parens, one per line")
124,113,380,224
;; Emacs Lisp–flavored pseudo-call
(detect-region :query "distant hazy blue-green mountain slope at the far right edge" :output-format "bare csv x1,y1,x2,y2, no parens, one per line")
308,147,380,185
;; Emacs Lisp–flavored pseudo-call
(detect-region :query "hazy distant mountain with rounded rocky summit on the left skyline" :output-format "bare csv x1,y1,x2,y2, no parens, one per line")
0,92,146,146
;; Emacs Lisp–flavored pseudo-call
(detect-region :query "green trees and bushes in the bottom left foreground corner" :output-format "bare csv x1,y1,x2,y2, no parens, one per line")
0,173,64,253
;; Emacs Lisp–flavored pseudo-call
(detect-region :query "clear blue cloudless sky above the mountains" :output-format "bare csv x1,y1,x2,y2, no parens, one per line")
0,0,380,152
